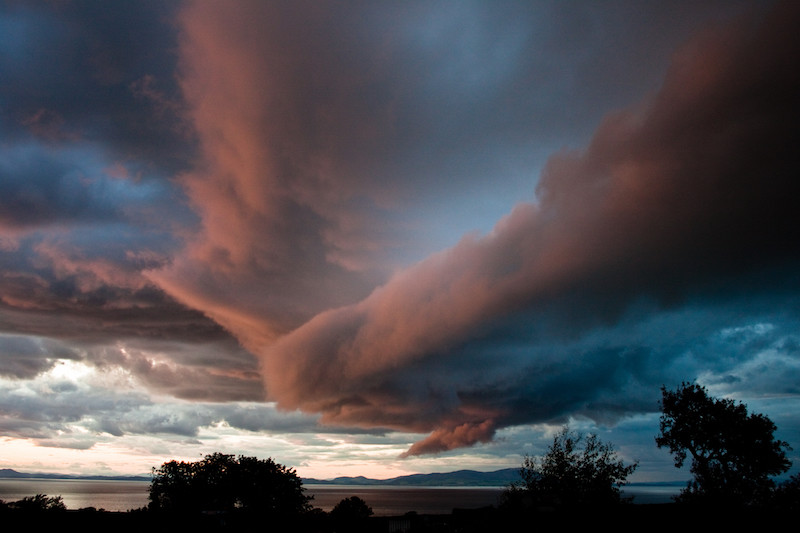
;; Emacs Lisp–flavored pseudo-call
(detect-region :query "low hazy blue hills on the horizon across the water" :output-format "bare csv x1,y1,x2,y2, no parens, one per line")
0,468,519,487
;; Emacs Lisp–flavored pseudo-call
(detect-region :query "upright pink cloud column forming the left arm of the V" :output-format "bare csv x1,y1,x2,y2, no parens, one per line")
151,2,412,343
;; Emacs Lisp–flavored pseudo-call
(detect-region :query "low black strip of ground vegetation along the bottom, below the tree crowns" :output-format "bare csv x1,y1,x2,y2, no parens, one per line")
0,494,797,533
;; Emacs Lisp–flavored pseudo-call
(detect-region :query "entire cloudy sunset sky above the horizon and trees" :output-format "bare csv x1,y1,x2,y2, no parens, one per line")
0,0,800,481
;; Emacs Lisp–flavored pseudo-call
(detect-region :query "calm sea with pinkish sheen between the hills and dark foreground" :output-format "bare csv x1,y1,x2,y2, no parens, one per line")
0,478,681,516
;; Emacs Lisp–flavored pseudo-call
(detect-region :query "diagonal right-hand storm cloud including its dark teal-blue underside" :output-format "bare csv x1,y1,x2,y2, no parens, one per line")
261,4,800,454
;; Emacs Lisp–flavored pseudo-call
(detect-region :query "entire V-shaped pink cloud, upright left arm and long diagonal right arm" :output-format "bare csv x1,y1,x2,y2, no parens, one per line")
149,2,800,454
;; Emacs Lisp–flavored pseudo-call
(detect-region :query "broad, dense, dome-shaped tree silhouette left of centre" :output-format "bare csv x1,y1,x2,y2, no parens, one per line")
149,453,311,516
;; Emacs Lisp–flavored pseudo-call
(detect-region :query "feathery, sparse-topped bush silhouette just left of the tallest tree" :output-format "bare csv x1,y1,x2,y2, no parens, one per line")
502,427,638,509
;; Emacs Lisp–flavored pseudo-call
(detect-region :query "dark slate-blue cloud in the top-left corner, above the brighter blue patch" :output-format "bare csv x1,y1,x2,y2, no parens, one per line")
0,1,188,170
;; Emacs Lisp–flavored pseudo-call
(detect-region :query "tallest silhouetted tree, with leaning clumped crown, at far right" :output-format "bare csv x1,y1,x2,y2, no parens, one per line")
656,383,791,506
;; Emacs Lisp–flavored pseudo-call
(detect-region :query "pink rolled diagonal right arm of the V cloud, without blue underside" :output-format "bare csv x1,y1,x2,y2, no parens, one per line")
258,1,800,454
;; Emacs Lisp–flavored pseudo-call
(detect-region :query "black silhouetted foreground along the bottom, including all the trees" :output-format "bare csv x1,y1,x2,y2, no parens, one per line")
0,384,800,533
